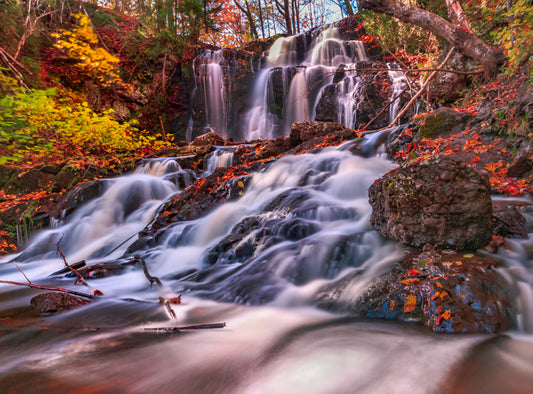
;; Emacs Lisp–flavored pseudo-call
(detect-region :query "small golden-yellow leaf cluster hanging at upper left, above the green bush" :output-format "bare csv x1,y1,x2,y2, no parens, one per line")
52,14,121,86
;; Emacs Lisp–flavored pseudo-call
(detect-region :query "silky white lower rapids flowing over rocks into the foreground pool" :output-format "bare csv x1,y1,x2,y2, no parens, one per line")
0,137,533,393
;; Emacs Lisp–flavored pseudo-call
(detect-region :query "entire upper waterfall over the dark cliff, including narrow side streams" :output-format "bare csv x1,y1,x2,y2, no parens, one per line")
188,21,406,141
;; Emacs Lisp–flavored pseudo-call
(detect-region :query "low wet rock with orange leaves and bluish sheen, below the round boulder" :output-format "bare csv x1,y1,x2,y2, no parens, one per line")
355,251,511,334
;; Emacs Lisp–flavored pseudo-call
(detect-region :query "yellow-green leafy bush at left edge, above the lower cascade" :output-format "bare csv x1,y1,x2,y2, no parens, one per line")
0,76,164,164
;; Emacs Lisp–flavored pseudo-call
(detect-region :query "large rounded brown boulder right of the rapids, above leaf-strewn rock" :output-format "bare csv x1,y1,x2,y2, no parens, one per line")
369,155,492,250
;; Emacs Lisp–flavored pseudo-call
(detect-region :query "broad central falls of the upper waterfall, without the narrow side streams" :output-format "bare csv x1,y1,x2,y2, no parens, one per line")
243,25,368,139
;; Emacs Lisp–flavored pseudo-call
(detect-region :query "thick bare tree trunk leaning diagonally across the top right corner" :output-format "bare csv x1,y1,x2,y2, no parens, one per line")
359,0,505,75
